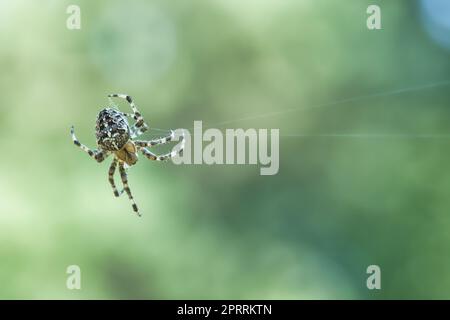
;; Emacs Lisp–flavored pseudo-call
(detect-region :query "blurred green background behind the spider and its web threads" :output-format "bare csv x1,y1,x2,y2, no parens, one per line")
0,0,450,299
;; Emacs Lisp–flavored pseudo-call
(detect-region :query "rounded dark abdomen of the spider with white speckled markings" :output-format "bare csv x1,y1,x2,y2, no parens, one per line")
95,108,130,151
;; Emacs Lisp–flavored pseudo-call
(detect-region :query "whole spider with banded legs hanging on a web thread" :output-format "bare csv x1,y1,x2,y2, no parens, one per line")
70,94,184,216
